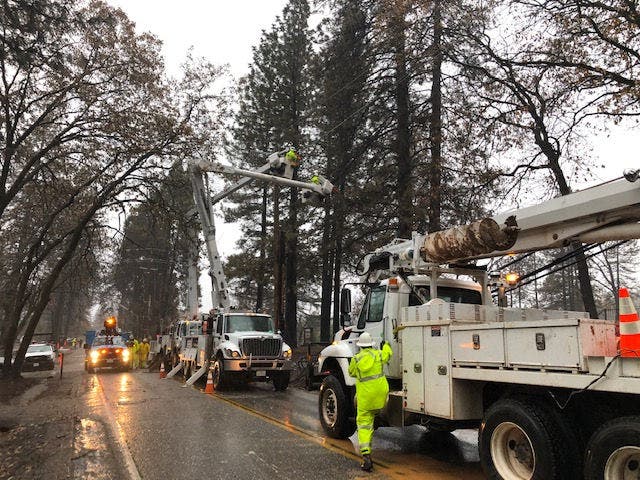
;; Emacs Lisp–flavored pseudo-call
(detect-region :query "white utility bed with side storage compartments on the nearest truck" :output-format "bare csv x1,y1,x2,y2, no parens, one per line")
400,303,640,420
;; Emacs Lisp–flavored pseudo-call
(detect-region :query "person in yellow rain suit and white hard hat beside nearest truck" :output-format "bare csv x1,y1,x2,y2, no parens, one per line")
349,332,393,472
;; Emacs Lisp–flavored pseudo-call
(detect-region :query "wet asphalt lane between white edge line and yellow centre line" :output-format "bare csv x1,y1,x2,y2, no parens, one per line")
93,371,368,480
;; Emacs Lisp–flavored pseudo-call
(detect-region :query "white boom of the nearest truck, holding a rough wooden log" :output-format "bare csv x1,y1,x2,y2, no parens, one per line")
358,170,640,274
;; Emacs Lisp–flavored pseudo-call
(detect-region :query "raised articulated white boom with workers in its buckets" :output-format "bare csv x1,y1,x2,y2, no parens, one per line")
189,150,333,309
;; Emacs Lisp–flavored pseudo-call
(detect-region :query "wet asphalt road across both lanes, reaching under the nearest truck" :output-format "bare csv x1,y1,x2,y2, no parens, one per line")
84,354,484,480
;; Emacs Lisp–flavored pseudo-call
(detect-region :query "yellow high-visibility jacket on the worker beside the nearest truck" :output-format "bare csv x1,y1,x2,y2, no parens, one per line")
349,343,393,410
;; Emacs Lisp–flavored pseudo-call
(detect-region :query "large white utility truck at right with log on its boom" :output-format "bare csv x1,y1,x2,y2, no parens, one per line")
316,170,640,480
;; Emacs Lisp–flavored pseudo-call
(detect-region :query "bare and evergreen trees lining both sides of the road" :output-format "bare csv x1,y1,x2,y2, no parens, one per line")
0,0,640,377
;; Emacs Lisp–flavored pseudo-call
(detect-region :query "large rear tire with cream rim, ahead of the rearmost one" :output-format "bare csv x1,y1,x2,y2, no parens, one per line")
478,398,580,480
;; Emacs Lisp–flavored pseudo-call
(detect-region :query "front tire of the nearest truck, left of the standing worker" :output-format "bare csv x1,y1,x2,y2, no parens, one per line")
318,375,356,438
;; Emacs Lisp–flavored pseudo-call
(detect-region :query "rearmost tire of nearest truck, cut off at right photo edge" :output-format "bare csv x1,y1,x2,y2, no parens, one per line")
584,416,640,480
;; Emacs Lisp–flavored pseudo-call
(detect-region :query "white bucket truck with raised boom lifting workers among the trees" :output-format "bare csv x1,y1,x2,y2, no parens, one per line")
159,149,333,390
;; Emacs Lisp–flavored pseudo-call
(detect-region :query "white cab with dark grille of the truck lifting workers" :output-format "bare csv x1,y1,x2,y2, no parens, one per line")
210,311,292,391
